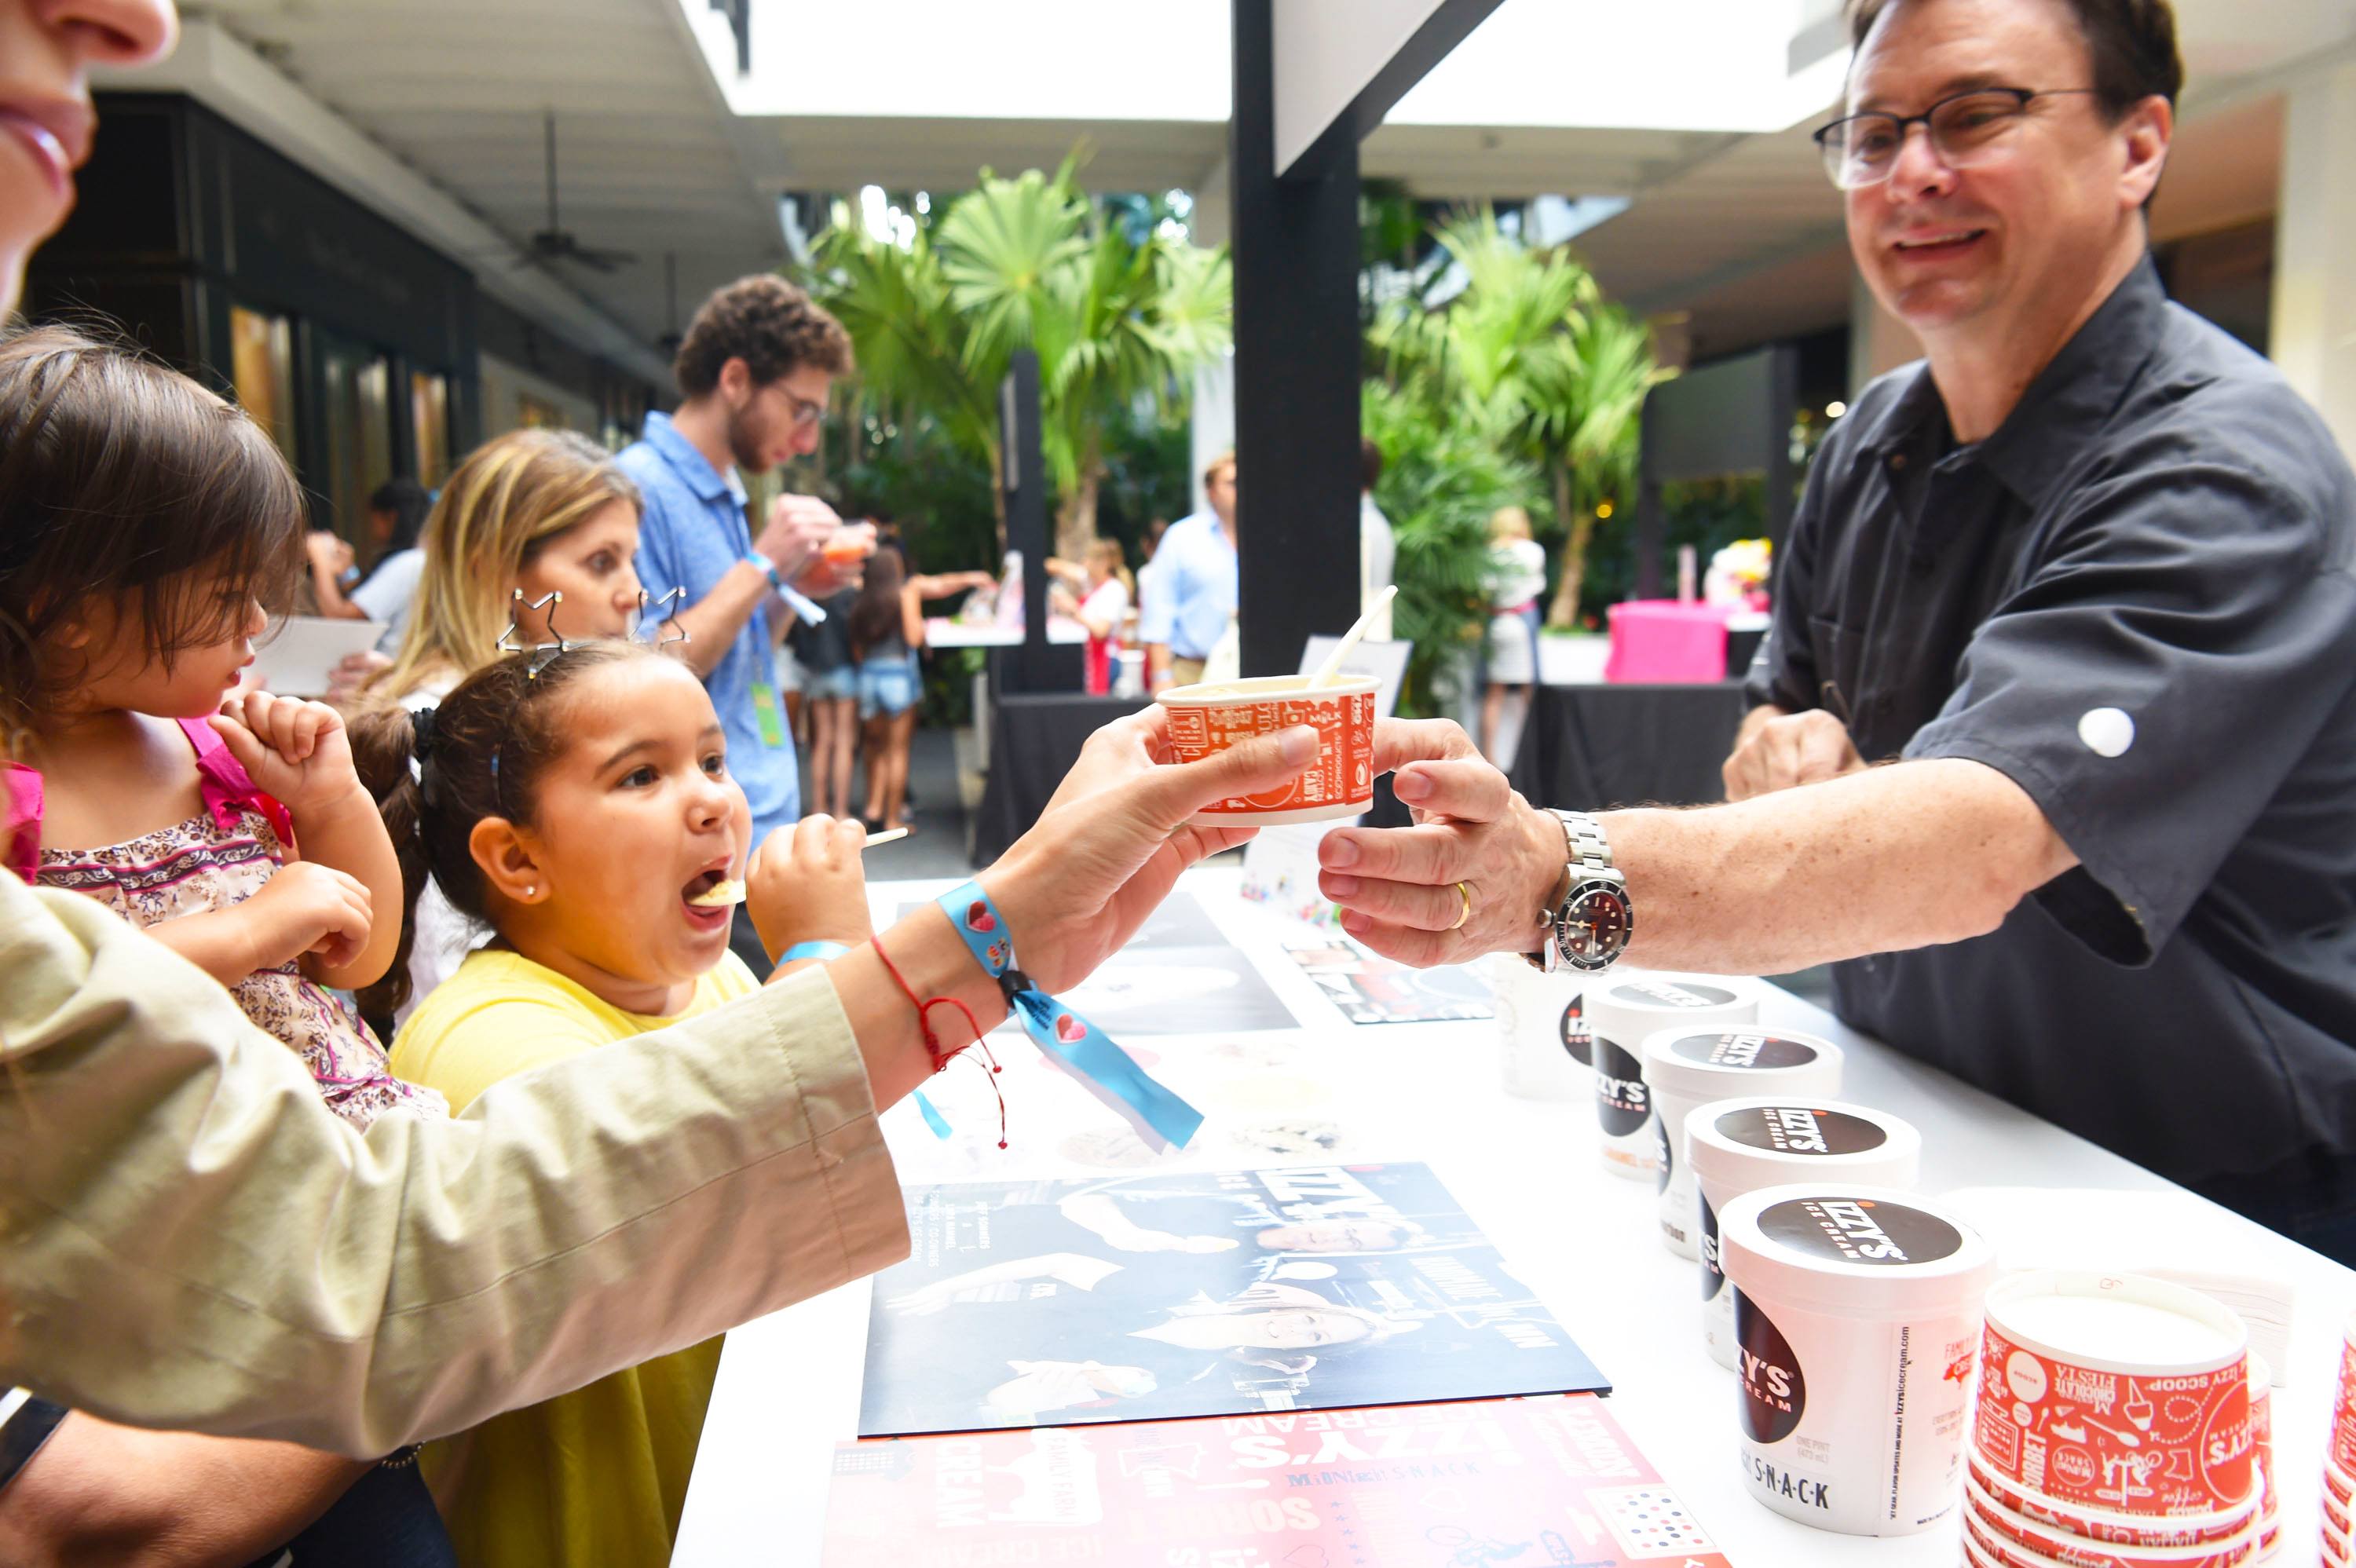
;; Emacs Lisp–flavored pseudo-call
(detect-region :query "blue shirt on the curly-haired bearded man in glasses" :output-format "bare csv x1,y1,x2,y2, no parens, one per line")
615,415,801,845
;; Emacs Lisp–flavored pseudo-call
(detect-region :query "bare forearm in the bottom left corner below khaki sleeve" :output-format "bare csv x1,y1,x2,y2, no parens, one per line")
0,1410,370,1568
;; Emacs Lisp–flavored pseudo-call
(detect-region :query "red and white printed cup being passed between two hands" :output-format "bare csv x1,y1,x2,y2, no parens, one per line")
1157,676,1376,826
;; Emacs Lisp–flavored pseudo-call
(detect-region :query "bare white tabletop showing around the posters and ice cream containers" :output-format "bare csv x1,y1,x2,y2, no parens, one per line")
671,868,2356,1568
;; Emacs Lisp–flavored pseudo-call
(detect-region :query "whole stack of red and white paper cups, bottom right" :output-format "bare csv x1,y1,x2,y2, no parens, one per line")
1963,1269,2264,1568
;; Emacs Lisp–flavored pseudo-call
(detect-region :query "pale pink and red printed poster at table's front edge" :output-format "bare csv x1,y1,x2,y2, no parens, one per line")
825,1394,1727,1568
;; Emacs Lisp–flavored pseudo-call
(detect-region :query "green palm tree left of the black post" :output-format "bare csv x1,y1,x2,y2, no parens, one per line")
813,155,1235,561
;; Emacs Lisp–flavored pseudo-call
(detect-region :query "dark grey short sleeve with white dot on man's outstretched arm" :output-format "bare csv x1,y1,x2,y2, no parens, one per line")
1906,462,2356,965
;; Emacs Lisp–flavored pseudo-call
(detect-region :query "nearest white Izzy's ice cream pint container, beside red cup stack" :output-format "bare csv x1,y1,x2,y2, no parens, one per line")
1718,1177,1996,1535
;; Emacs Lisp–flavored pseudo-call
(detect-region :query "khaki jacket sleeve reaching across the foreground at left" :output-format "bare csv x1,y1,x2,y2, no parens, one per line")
0,871,907,1457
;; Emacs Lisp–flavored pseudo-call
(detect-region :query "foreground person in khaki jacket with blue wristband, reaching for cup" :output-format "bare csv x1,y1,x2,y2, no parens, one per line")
0,0,1357,1469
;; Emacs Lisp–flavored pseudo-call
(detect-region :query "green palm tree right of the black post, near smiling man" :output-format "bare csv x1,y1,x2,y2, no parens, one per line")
1374,205,1670,627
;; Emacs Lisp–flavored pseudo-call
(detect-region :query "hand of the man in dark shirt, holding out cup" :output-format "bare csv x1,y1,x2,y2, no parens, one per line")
1317,718,1564,967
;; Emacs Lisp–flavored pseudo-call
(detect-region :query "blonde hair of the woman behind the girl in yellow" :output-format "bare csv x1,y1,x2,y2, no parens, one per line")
363,431,638,704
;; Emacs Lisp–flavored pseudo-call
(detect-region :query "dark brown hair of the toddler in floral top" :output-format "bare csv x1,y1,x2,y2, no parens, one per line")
0,327,306,751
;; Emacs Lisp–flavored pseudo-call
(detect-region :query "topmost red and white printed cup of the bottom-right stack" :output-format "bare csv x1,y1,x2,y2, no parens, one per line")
1974,1269,2255,1514
